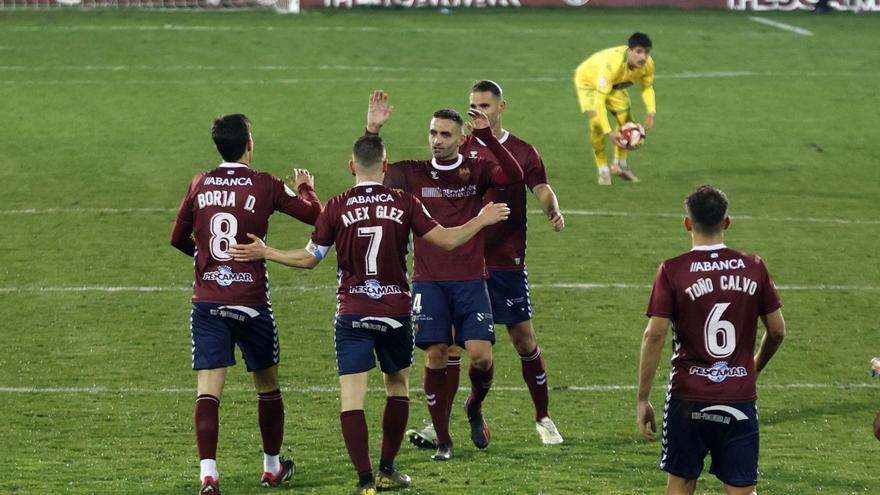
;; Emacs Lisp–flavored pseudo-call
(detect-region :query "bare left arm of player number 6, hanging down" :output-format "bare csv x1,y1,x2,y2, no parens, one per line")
636,316,670,440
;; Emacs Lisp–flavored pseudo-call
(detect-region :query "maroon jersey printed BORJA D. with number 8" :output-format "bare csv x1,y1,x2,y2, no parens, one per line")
171,163,321,305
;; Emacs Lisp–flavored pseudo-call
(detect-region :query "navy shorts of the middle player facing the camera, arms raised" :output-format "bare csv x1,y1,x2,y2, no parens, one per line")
413,280,495,349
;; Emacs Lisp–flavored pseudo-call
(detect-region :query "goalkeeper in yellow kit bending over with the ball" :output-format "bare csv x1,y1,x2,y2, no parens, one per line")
574,33,657,186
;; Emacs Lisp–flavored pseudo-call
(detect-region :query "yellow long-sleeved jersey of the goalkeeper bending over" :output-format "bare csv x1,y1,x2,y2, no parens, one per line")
574,45,657,133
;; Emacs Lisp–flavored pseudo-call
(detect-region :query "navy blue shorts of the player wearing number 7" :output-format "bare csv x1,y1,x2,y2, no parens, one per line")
334,315,415,375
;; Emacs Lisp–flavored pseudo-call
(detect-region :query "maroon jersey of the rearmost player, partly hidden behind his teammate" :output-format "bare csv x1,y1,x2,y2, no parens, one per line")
460,130,547,271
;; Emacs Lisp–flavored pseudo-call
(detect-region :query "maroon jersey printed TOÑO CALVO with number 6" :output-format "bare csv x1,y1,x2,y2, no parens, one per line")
647,244,782,403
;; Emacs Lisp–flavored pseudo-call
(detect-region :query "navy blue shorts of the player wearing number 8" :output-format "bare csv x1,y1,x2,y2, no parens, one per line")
190,303,280,371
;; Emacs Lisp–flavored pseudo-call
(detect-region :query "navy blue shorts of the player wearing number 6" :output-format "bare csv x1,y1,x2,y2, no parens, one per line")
660,399,758,487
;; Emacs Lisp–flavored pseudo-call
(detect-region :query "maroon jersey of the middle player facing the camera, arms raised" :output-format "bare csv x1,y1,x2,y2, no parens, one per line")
385,154,497,281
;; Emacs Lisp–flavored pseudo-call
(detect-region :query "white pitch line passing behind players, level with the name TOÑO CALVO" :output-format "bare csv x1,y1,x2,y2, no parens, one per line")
0,282,880,293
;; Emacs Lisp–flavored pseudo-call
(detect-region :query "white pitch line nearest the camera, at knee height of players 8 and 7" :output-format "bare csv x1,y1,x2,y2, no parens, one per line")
0,383,880,394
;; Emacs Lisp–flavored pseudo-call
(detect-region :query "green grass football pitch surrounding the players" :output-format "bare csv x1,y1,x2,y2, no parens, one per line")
0,8,880,494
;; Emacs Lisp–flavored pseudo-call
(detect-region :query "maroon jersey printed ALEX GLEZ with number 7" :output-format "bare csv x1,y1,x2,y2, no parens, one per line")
308,182,438,316
